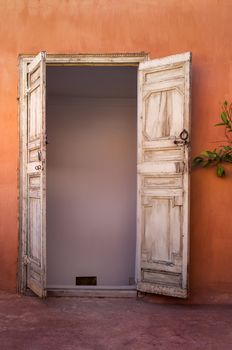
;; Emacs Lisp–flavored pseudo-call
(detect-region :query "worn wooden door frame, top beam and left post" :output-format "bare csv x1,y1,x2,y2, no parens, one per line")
17,52,149,294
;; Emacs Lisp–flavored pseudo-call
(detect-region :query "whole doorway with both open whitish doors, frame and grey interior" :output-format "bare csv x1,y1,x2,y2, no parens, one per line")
18,51,191,298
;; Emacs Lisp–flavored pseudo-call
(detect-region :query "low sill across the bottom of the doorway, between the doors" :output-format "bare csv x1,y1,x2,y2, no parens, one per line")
47,286,137,298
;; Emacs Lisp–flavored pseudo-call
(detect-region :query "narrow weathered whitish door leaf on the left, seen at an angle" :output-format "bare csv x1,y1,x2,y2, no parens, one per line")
24,52,46,297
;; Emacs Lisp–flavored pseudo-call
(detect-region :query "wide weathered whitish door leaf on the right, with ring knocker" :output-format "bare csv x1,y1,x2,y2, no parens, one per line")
137,53,191,298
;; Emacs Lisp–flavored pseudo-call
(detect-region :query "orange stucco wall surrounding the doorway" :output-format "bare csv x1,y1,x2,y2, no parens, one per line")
0,0,232,302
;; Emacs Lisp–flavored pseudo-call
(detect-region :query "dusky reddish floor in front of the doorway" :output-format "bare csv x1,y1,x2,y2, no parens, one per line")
0,293,232,350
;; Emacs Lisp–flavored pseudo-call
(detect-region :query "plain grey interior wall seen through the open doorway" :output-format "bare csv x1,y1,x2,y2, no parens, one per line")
47,67,136,286
